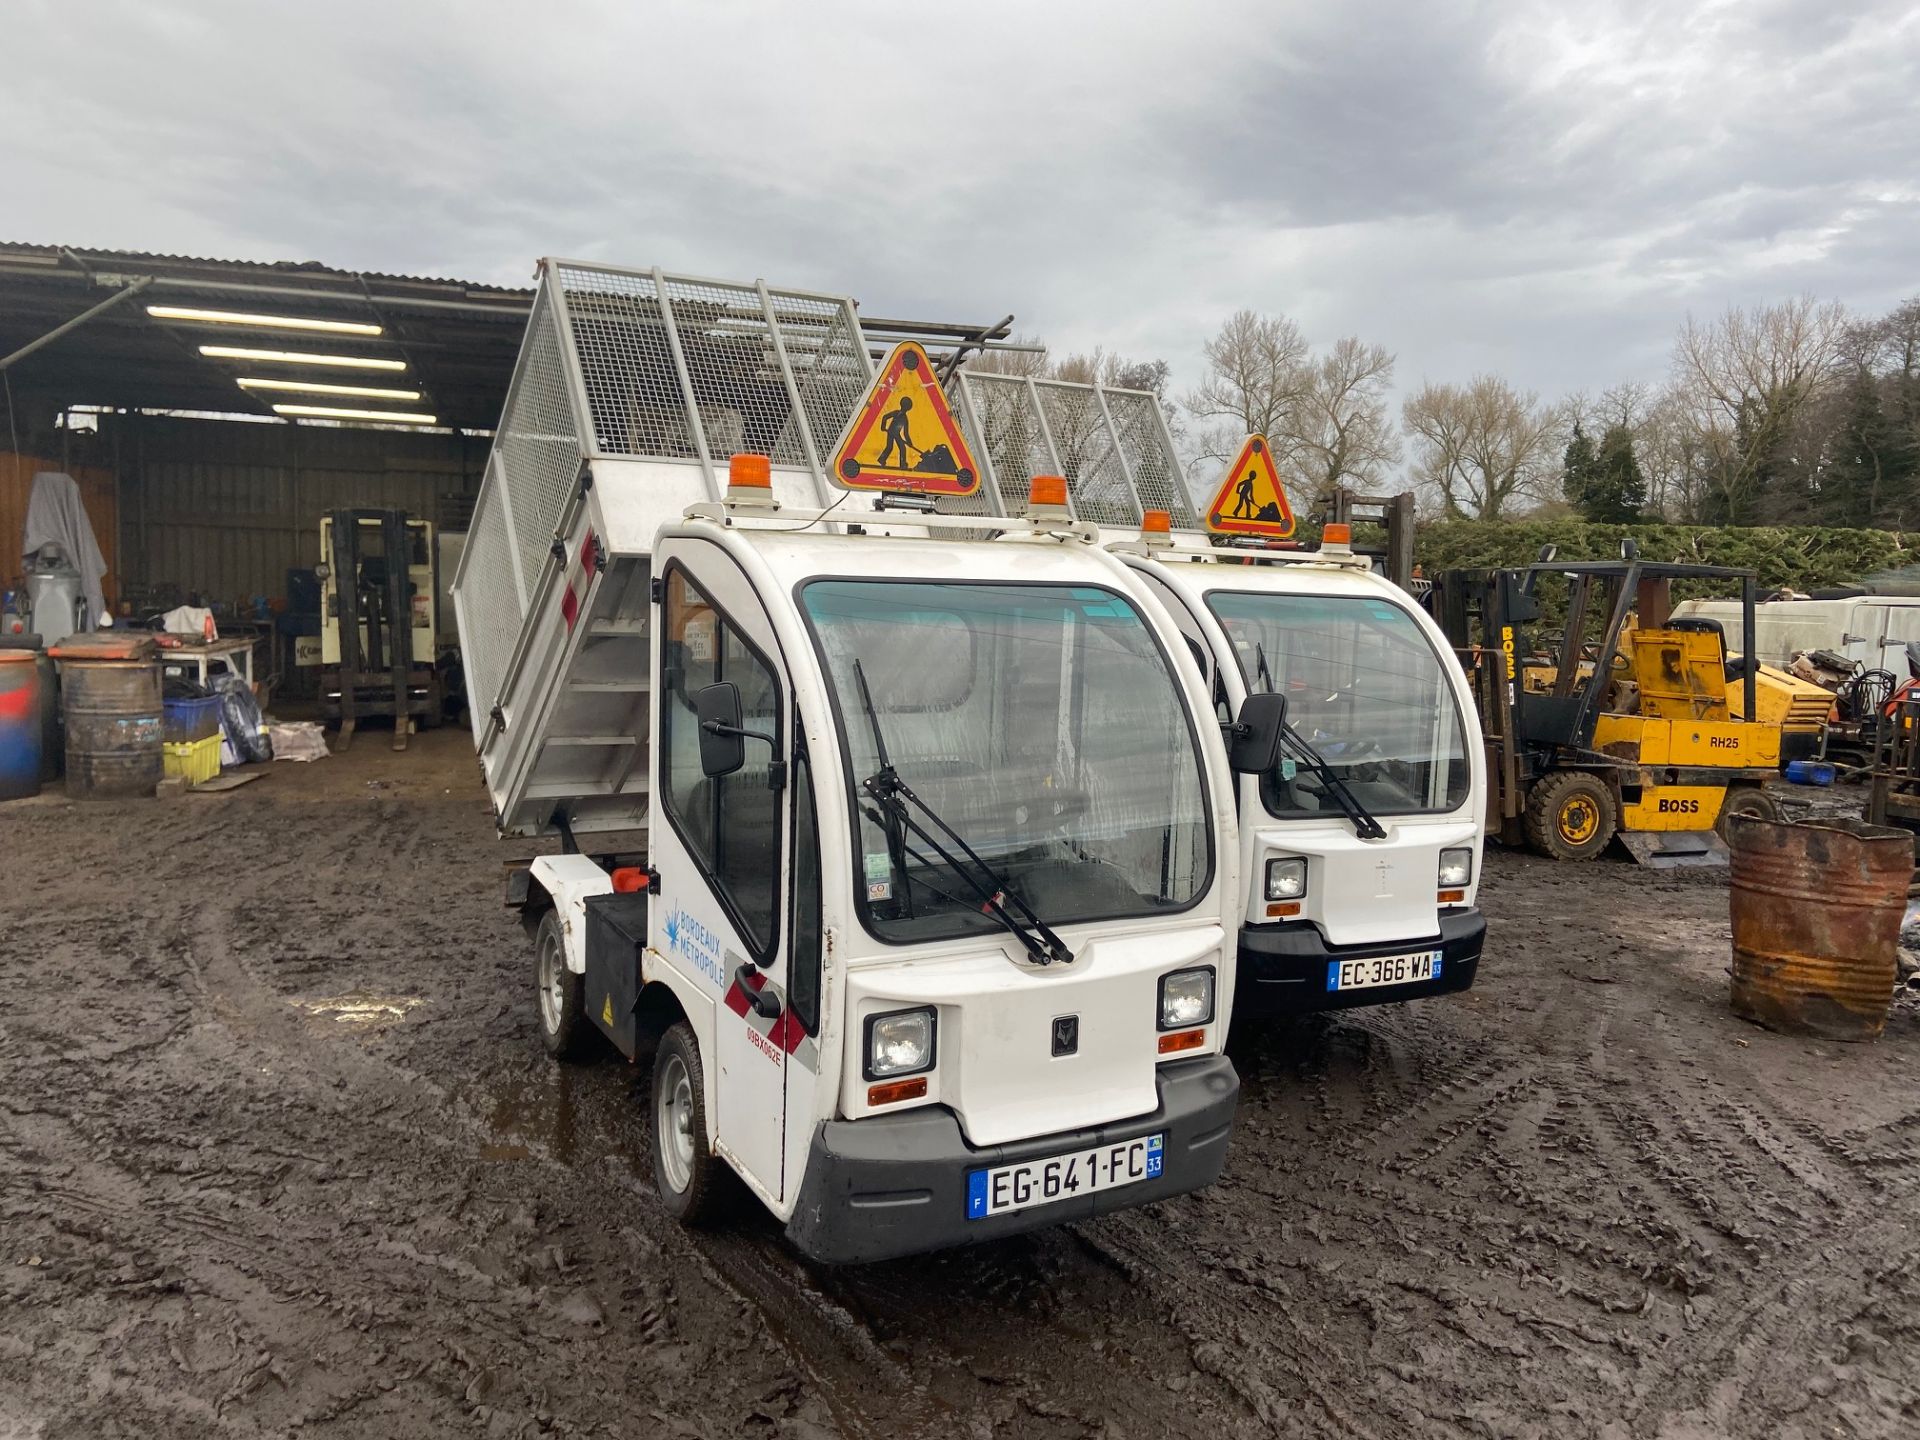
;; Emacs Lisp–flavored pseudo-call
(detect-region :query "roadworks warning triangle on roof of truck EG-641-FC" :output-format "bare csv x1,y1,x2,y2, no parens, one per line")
829,340,979,495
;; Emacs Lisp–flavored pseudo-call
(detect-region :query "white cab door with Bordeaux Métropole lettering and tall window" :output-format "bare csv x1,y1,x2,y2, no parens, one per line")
649,541,793,1202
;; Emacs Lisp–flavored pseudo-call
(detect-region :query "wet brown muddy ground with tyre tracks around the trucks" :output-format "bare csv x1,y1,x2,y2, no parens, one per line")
0,732,1920,1440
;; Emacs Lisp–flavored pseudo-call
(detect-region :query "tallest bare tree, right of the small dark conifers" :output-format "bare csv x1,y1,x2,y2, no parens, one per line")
1672,296,1847,524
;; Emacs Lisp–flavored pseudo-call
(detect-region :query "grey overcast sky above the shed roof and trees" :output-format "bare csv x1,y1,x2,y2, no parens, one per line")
11,0,1920,416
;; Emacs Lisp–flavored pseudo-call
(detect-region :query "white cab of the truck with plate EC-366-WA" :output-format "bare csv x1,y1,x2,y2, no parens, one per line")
1112,522,1486,1020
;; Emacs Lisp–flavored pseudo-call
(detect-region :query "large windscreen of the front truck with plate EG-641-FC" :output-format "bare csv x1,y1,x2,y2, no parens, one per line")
803,580,1213,943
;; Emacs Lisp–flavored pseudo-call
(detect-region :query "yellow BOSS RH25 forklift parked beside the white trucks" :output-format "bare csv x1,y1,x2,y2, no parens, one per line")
1430,541,1797,868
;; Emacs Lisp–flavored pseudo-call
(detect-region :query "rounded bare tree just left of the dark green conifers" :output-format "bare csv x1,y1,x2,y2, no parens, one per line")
1402,374,1561,520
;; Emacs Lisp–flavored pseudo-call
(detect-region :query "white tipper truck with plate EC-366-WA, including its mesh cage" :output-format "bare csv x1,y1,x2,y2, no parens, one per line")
929,371,1486,1020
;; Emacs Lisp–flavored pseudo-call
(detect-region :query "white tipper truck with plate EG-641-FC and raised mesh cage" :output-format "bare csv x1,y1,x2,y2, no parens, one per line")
441,261,1283,1261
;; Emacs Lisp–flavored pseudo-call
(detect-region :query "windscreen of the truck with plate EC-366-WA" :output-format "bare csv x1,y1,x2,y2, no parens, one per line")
1208,591,1469,816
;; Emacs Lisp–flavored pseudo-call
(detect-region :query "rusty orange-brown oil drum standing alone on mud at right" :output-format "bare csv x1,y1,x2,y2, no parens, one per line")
1728,816,1914,1041
